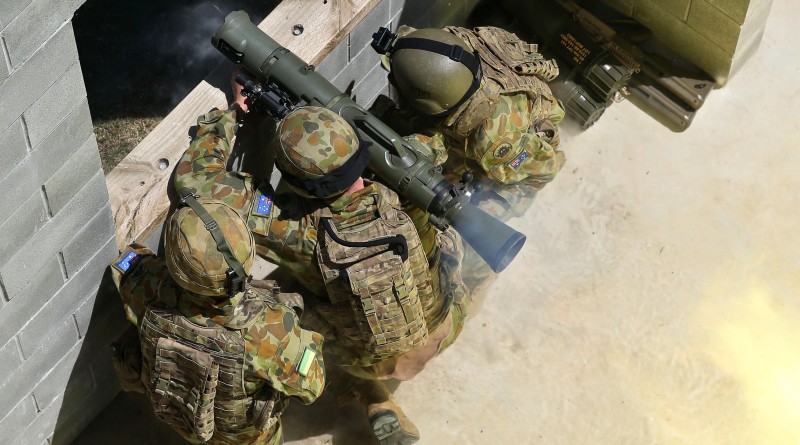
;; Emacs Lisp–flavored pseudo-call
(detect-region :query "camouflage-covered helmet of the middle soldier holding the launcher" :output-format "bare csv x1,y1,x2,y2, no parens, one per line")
275,106,363,198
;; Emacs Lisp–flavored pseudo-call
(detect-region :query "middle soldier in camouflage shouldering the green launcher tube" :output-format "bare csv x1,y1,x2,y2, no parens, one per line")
175,81,468,445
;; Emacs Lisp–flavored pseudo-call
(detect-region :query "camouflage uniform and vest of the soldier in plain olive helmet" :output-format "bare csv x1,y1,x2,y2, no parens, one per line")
373,26,565,220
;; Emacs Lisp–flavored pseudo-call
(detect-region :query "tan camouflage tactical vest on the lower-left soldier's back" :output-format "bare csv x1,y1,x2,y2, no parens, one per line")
140,291,288,442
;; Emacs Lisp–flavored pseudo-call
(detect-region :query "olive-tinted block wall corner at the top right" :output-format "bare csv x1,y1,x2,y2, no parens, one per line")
605,0,772,85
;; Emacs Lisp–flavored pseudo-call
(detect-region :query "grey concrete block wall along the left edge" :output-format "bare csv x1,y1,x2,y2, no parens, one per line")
0,0,125,445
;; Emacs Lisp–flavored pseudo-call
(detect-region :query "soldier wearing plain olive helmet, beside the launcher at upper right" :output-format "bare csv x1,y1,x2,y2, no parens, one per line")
371,26,565,302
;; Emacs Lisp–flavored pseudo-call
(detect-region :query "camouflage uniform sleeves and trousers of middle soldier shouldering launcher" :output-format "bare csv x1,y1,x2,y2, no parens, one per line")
175,111,469,372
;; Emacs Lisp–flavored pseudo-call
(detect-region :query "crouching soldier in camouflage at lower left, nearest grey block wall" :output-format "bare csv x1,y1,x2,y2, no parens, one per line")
111,196,325,445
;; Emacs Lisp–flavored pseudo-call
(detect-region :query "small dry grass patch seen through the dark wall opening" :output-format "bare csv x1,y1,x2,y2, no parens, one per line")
94,117,163,174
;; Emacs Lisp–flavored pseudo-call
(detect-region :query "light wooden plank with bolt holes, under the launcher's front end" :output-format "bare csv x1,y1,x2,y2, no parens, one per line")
106,0,380,249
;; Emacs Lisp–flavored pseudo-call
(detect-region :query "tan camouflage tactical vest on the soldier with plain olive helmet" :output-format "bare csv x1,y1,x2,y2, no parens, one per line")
444,26,558,139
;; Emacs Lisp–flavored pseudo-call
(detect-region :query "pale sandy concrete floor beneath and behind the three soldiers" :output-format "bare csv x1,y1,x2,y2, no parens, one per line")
76,0,800,445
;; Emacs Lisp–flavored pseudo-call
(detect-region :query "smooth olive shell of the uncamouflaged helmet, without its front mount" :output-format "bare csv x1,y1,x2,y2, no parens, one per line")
390,28,476,116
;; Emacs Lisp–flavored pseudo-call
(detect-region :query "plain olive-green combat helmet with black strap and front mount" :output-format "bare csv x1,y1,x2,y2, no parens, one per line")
372,28,482,116
